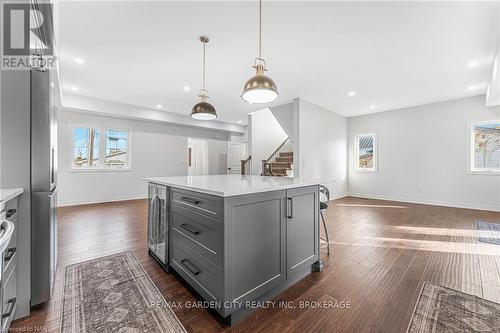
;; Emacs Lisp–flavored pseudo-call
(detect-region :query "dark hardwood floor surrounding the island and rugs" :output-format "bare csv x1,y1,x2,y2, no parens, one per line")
12,197,500,332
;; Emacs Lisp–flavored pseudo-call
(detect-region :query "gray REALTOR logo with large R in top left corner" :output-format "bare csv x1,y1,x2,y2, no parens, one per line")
2,3,55,69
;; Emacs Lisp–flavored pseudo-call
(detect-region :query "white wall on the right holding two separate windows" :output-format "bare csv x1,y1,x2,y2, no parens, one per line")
349,96,500,210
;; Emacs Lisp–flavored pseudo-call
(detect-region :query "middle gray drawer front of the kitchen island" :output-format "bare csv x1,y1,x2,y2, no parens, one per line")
171,205,223,267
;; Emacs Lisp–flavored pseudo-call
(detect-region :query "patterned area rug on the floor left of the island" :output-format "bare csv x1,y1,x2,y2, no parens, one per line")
61,251,186,333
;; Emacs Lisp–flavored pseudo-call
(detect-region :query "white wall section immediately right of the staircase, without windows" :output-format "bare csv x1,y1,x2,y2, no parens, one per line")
295,99,348,198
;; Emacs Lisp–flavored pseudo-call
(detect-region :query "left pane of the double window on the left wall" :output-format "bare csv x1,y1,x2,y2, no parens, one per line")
73,127,99,168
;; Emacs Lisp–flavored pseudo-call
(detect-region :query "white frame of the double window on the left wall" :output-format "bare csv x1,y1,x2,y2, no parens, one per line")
69,124,133,172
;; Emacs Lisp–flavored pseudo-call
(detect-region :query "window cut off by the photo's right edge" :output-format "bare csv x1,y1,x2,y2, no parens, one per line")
470,120,500,173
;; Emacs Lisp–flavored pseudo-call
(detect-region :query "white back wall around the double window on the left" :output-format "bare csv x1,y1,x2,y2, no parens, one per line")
58,111,228,205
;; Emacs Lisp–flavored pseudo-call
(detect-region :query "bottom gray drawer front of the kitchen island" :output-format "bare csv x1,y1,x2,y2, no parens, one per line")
170,233,222,300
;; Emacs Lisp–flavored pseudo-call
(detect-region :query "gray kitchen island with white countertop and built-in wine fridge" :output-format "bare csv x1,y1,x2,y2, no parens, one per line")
146,175,321,324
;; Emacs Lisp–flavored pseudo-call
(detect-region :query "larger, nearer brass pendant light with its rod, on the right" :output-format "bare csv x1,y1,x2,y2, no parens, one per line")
241,0,279,104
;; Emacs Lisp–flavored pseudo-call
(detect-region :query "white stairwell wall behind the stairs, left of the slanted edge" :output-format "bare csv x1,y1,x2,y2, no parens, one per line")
248,109,287,175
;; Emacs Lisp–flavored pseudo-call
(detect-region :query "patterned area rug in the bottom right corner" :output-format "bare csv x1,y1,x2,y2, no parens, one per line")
407,282,500,333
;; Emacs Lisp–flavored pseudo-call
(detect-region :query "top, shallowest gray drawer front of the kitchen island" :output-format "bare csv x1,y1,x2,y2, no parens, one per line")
172,188,224,220
